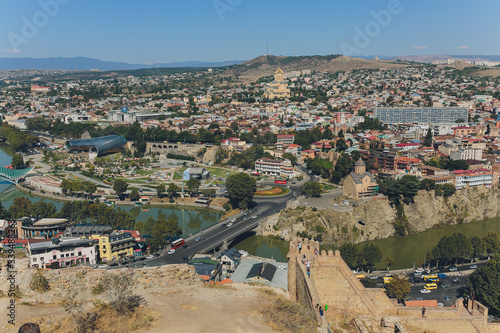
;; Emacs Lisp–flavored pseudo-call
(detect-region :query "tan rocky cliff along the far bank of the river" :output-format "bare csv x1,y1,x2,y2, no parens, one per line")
274,185,500,245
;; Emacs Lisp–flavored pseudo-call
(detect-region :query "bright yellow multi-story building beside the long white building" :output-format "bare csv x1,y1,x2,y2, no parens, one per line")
90,231,136,261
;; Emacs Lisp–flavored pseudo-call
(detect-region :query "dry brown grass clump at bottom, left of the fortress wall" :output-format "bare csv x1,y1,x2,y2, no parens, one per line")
261,289,318,333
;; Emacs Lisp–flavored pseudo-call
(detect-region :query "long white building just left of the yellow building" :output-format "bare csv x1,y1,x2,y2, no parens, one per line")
27,238,98,268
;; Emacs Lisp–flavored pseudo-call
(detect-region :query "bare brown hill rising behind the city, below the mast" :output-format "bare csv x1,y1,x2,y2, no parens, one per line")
223,55,407,82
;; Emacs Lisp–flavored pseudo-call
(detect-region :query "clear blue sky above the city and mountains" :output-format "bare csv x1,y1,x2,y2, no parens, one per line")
0,0,500,63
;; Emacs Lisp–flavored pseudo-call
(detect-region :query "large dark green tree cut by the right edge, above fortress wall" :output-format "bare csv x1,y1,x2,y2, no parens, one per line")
467,260,500,315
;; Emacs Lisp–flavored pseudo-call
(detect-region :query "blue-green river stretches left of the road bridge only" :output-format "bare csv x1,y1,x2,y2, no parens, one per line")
0,143,222,237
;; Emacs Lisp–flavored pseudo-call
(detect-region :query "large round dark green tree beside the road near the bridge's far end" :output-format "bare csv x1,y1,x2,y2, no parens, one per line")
226,173,257,209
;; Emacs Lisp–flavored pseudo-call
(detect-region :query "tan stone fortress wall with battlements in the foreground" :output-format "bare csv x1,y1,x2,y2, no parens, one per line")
287,238,500,333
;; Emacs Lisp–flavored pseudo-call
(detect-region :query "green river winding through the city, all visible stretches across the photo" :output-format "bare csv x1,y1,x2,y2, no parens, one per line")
5,143,500,269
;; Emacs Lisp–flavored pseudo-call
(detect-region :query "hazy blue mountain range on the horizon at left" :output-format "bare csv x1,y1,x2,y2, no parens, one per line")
0,57,244,71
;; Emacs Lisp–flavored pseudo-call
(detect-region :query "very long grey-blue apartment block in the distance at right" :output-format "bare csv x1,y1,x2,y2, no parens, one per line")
375,107,469,124
